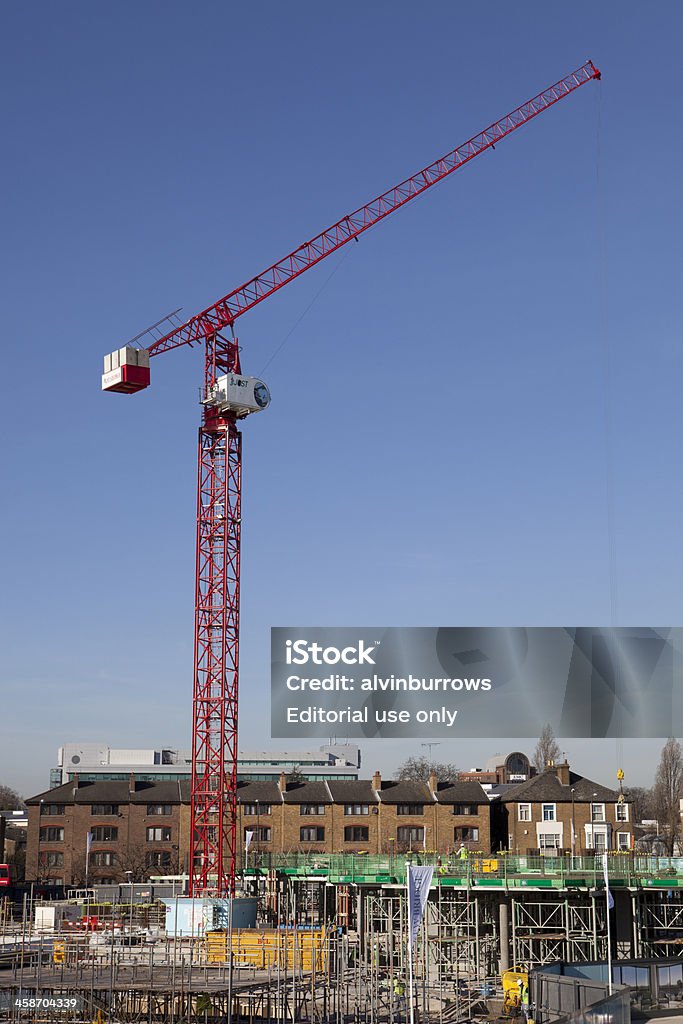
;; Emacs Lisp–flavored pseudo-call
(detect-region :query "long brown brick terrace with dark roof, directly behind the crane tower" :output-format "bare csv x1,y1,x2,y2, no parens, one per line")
27,772,492,885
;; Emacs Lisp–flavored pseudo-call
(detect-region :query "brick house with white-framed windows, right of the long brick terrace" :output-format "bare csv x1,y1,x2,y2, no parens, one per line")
500,762,633,856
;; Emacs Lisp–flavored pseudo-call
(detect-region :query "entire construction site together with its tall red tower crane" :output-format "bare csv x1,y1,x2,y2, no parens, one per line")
7,60,663,1024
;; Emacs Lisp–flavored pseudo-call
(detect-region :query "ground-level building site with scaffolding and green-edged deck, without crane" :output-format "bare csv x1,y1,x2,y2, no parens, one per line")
5,856,683,1024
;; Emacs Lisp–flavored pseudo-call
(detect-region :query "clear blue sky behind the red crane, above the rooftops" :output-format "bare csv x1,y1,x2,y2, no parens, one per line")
0,0,683,794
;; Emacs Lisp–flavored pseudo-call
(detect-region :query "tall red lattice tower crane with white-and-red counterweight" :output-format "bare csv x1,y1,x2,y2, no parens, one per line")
102,60,600,895
